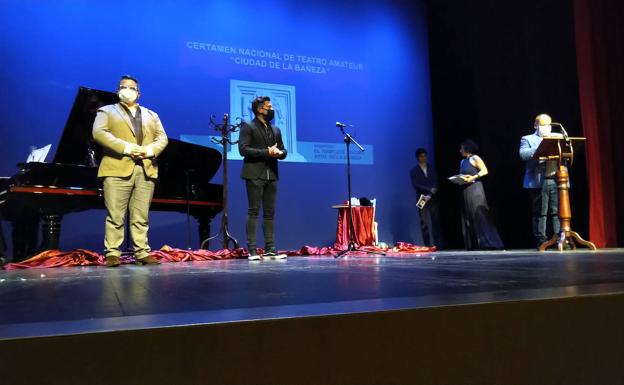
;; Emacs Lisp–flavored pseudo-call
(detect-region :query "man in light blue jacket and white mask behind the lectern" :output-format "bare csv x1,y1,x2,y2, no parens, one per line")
520,114,561,248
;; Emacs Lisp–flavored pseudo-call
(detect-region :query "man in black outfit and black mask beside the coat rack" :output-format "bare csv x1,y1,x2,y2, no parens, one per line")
238,96,288,260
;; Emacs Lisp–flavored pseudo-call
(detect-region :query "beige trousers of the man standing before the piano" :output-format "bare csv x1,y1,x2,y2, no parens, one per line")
104,165,155,258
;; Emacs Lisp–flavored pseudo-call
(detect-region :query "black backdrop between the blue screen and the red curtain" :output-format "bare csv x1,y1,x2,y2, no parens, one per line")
428,0,588,248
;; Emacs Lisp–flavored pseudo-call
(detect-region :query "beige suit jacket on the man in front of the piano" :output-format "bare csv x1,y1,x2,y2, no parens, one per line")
93,103,168,179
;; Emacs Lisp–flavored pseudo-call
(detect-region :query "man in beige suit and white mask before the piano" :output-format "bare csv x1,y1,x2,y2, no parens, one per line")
93,75,167,267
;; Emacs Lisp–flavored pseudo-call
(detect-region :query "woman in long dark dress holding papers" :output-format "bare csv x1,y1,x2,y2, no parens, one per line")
459,140,503,250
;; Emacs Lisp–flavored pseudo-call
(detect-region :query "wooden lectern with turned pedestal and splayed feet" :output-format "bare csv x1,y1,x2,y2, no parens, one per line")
533,137,596,251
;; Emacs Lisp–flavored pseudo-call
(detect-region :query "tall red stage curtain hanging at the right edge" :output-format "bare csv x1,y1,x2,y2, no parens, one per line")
574,0,624,247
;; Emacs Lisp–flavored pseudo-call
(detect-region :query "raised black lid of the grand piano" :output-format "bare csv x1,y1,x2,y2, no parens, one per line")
53,87,221,185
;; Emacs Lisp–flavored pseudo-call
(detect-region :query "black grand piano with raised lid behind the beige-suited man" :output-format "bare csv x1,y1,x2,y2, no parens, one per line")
0,87,223,260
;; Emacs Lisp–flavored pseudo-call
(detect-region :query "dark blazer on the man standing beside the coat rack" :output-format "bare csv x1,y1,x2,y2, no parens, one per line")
238,119,288,180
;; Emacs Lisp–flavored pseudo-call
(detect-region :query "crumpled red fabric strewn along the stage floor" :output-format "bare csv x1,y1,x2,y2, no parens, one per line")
4,242,436,270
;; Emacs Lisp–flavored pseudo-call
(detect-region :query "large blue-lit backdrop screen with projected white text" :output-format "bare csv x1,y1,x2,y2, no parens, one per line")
0,0,433,251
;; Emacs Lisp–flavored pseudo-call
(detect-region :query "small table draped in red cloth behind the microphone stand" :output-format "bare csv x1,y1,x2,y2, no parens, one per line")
332,204,377,249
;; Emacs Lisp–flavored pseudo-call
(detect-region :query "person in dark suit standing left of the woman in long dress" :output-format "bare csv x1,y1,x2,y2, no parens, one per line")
410,148,444,249
